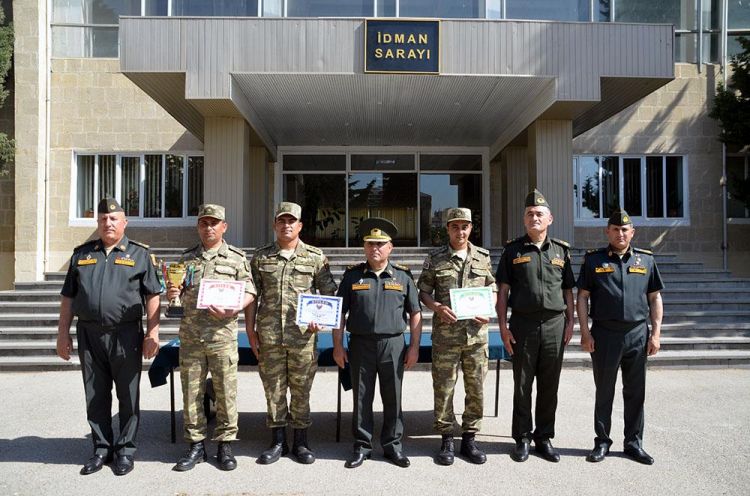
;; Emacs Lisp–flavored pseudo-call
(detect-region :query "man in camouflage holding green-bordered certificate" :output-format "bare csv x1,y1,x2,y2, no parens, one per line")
417,208,497,465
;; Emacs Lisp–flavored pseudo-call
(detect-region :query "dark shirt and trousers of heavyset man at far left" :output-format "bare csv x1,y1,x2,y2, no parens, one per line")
60,236,161,457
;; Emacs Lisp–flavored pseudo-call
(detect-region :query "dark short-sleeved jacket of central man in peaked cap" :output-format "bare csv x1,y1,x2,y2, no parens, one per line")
338,262,422,336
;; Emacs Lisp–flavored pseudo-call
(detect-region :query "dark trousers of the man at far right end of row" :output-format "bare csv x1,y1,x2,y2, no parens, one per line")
591,320,648,449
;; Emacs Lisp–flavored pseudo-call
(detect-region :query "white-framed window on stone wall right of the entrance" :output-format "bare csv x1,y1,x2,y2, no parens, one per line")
573,155,688,223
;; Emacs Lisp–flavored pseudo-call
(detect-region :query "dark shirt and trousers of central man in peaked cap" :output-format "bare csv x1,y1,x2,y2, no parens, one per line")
338,262,421,454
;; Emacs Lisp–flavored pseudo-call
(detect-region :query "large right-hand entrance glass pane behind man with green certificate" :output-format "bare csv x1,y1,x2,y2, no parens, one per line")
419,174,482,246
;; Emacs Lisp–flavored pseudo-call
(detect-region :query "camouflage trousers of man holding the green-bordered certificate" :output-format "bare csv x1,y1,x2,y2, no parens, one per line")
432,343,489,434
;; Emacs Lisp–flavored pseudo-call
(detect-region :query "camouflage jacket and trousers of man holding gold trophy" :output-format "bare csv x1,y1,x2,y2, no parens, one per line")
180,241,256,442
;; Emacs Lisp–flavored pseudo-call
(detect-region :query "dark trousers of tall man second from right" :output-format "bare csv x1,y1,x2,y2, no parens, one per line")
509,313,565,442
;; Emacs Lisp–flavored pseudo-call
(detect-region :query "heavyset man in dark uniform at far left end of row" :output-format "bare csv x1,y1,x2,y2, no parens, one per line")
57,198,161,475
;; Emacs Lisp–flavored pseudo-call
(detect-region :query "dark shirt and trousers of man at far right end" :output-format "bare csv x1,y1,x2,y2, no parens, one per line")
578,247,664,449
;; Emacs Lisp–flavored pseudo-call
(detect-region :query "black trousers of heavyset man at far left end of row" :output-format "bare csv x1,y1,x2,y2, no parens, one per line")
76,321,143,456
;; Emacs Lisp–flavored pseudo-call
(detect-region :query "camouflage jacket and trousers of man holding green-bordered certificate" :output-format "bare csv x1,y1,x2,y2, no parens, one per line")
417,243,497,434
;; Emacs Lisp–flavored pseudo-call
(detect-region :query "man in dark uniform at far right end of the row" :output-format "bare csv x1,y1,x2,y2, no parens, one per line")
577,210,664,465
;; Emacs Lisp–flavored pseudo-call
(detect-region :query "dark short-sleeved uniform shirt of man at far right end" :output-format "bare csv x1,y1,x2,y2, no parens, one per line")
578,247,664,322
